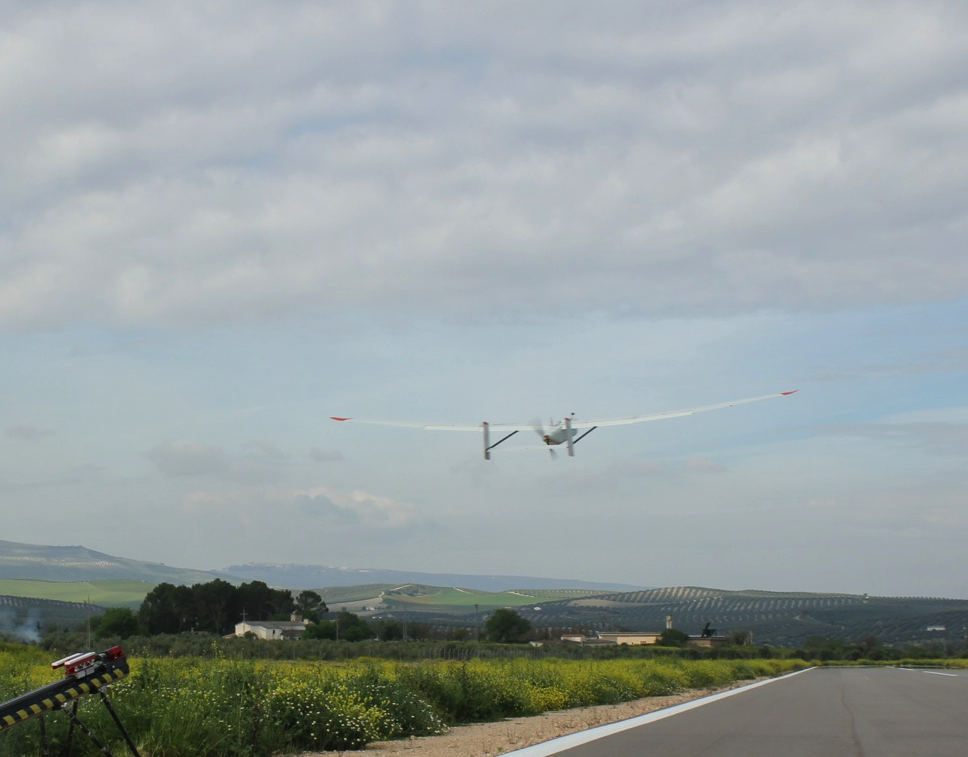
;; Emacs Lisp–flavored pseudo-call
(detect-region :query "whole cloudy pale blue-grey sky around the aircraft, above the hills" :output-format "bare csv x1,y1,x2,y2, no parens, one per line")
0,0,968,598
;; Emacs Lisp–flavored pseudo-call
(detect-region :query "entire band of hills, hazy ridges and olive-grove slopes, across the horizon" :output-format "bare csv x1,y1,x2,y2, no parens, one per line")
0,541,968,648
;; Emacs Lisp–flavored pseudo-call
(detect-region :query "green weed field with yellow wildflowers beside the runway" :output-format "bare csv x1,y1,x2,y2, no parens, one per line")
0,648,805,757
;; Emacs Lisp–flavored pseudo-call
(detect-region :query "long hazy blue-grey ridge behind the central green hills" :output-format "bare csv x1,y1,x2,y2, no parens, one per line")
221,563,642,592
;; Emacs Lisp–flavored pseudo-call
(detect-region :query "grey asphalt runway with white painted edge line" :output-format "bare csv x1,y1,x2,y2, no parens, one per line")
511,668,968,757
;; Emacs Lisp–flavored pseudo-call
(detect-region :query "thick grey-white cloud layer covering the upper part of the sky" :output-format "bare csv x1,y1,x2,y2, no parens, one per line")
0,1,968,328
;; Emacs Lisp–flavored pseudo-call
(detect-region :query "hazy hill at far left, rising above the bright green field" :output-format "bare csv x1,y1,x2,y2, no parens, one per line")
0,540,220,585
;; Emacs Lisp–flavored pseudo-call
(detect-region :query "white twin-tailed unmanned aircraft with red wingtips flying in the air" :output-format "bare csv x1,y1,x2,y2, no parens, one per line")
330,389,797,460
